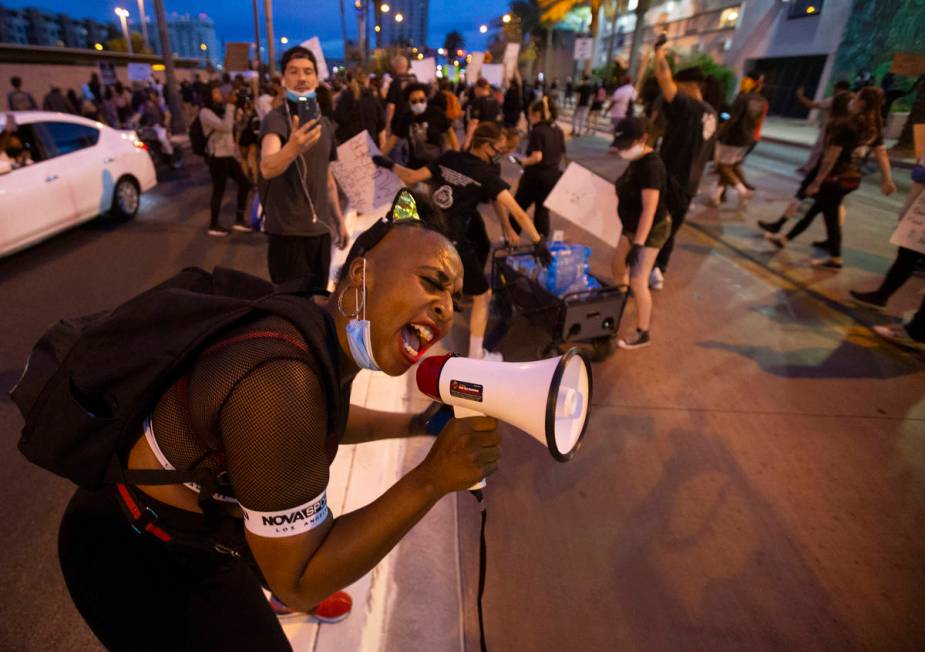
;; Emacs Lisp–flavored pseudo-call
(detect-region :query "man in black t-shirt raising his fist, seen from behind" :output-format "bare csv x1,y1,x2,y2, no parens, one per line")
640,39,717,290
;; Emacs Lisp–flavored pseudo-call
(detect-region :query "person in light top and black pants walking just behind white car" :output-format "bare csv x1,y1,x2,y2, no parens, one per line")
199,84,251,237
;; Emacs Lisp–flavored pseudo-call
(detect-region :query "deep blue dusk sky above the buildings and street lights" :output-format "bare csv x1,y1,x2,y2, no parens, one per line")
0,0,508,58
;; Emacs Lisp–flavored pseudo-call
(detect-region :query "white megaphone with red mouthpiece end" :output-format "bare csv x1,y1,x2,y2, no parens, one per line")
417,348,591,489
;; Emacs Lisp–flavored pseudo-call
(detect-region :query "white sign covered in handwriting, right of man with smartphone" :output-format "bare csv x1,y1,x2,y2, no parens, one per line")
331,131,404,213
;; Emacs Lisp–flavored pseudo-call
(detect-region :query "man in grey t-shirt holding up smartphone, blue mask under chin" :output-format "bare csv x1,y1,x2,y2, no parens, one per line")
258,46,349,287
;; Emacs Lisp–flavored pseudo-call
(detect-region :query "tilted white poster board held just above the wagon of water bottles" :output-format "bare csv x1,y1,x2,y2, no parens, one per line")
543,162,623,247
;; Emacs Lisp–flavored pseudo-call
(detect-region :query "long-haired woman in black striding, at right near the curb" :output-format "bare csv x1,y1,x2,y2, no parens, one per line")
766,86,896,270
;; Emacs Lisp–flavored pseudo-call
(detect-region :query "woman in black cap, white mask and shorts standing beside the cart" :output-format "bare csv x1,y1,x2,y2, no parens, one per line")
611,117,671,349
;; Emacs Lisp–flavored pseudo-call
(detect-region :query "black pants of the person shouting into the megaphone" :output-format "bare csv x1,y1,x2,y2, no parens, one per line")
58,487,291,651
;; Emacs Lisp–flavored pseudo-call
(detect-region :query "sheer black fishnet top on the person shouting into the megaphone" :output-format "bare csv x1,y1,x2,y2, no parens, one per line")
152,317,340,512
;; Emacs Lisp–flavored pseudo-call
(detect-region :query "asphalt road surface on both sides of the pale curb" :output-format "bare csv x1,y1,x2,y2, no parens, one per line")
0,140,925,651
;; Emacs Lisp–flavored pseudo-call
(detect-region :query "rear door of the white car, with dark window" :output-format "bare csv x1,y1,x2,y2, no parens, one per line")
41,120,115,222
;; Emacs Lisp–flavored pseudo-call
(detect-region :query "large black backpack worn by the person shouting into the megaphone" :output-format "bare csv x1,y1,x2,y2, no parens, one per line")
10,268,346,497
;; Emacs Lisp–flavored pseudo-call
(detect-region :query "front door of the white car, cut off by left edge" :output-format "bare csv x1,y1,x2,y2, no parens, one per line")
0,125,74,254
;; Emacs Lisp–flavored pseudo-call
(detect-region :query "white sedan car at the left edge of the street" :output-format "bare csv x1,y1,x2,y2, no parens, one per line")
0,111,157,256
